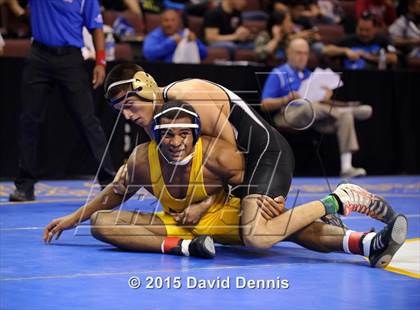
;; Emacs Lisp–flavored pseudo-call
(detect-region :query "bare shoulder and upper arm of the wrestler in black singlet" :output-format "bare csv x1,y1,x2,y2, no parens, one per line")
168,79,236,147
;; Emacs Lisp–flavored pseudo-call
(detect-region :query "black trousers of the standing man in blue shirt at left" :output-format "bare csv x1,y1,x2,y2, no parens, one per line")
15,45,114,192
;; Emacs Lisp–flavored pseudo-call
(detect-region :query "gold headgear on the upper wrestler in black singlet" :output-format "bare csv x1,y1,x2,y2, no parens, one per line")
105,71,159,107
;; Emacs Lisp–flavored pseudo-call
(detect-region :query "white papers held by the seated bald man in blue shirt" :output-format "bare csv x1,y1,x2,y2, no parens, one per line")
298,68,343,102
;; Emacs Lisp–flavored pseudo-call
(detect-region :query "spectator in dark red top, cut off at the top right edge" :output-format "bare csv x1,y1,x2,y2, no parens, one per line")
354,0,397,28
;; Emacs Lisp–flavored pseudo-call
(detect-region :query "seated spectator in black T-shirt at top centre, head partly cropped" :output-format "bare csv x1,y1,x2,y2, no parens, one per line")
203,0,254,49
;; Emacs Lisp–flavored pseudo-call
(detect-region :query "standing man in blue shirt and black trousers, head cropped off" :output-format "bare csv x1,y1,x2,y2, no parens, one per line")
10,0,114,201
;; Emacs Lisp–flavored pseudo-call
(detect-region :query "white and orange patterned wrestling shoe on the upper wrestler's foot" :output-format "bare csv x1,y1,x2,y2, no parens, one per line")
333,183,397,224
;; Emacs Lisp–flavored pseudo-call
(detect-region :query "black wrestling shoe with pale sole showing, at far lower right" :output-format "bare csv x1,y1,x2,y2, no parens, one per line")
369,214,408,268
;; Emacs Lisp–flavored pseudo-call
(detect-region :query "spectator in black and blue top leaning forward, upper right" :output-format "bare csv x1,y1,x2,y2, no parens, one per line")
322,13,397,70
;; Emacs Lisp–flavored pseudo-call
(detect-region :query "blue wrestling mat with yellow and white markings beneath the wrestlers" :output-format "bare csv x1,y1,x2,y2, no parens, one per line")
0,176,420,310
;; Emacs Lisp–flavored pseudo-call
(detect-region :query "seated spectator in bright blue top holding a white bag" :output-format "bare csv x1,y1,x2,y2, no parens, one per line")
143,10,207,63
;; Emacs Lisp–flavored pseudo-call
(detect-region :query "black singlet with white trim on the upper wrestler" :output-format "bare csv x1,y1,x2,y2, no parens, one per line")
229,100,295,198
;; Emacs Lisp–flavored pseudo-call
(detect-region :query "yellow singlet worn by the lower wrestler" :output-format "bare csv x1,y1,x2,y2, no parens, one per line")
148,138,242,244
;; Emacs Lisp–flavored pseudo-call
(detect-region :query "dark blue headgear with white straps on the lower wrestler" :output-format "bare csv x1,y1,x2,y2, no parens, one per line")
151,106,201,145
